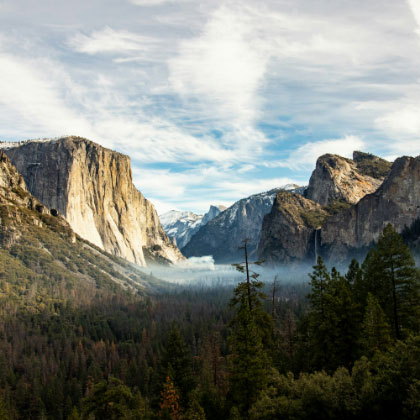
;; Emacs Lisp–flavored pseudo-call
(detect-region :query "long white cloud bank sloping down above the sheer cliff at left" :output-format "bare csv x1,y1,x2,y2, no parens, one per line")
0,50,235,163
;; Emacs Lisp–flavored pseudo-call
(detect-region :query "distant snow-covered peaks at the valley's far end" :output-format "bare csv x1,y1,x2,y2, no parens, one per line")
159,206,226,250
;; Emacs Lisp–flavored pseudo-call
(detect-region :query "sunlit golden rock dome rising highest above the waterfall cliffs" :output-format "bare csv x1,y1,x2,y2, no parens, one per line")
305,152,386,206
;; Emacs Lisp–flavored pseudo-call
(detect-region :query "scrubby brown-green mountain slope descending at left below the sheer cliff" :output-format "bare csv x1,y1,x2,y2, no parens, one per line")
0,151,164,308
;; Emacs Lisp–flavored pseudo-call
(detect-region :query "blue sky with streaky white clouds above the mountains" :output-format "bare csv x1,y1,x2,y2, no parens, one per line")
0,0,420,213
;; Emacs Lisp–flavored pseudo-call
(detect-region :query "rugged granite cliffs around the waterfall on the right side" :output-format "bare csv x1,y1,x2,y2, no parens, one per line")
258,152,420,264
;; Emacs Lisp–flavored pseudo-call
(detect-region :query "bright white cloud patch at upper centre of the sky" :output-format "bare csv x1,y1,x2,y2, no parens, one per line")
169,6,268,123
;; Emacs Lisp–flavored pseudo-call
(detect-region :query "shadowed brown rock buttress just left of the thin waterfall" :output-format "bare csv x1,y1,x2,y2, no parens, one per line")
258,191,328,264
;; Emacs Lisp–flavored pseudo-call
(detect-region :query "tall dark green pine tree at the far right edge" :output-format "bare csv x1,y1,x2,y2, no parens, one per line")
364,224,420,339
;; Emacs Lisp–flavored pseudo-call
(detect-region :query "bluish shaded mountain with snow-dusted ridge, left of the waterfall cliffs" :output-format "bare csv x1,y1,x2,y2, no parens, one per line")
182,185,304,263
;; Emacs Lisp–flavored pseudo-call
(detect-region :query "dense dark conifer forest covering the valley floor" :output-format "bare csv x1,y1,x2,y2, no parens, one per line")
0,225,420,420
